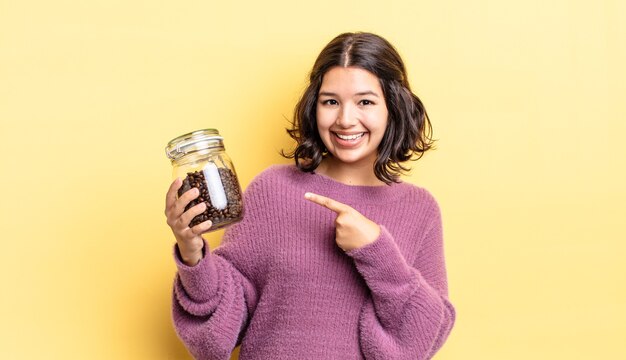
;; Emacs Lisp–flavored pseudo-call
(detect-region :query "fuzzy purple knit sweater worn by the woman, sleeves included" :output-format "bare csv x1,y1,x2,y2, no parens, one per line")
173,165,455,360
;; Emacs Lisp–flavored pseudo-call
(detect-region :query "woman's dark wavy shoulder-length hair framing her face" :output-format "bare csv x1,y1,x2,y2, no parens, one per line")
281,32,434,184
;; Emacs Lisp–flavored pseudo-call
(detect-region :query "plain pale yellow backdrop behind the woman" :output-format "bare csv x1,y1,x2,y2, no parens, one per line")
0,0,626,360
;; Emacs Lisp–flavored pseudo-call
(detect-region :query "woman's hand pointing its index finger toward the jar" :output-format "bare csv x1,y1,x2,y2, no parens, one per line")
304,193,380,251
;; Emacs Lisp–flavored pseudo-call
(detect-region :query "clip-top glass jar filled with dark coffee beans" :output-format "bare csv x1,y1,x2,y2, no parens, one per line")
165,129,243,231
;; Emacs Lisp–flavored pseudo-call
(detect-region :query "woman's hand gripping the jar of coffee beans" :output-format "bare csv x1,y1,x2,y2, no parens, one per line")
165,178,212,266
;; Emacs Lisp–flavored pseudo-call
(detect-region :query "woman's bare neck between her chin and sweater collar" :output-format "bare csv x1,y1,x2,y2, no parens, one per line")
315,157,385,186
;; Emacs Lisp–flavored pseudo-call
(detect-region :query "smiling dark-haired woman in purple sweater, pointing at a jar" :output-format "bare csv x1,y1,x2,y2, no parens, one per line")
165,33,455,360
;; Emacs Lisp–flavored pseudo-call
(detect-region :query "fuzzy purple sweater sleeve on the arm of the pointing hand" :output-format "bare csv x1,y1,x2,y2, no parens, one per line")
348,208,456,360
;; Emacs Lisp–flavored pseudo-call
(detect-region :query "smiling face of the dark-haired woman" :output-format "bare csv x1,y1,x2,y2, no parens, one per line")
317,66,388,165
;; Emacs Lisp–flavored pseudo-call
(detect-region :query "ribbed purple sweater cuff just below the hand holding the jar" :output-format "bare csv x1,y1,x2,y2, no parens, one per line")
174,241,219,302
